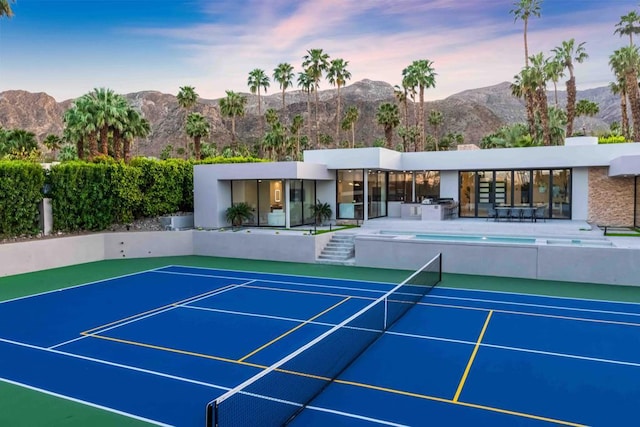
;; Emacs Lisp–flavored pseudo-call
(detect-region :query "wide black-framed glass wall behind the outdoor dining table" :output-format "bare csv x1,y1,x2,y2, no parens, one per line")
459,169,571,219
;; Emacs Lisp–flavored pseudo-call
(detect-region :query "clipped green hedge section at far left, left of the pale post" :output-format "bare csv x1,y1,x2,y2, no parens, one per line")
0,161,44,237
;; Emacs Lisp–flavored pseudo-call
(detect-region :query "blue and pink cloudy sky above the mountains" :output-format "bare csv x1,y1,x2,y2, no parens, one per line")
0,0,640,101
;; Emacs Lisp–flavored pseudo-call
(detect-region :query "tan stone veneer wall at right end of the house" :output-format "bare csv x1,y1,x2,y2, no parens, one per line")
587,167,634,226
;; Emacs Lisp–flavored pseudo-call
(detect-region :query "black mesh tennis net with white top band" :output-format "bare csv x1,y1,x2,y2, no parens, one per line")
206,254,442,427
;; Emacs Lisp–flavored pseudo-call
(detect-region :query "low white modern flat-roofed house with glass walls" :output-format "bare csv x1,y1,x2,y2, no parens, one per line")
194,138,640,228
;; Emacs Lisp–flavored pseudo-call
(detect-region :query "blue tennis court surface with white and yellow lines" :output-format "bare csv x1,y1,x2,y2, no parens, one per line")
0,266,640,427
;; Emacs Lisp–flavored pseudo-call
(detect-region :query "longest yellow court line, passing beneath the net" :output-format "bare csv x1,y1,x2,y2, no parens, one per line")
82,326,587,427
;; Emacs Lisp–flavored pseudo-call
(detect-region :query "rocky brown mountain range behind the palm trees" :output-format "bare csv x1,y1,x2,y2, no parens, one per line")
0,80,620,156
